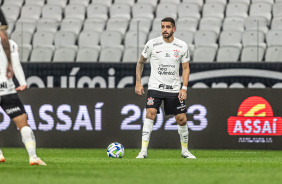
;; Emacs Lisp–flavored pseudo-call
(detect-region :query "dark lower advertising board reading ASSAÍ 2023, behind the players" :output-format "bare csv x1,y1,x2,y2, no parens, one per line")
0,88,282,150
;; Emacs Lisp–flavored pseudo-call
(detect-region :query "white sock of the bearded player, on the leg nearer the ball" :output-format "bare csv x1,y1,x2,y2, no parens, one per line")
141,118,154,152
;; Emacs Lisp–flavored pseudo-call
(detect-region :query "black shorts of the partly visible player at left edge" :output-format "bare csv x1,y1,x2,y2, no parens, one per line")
0,93,26,119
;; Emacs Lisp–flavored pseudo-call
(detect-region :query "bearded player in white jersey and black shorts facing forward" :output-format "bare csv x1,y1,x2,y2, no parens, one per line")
135,17,196,159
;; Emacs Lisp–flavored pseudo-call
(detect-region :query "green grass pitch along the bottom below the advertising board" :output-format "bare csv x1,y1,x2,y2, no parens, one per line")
0,148,282,184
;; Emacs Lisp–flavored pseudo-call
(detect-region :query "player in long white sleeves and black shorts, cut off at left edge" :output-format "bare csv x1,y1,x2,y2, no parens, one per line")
0,40,46,165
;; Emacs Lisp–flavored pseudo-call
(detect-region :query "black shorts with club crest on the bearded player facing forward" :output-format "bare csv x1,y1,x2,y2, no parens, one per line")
146,90,187,115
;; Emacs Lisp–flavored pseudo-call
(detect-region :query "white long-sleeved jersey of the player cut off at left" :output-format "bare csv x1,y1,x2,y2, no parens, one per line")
0,40,26,96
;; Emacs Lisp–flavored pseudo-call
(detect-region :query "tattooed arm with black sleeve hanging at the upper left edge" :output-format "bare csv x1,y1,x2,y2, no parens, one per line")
0,9,14,78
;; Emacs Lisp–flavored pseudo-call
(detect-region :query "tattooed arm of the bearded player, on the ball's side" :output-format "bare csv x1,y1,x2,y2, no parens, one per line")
135,55,147,95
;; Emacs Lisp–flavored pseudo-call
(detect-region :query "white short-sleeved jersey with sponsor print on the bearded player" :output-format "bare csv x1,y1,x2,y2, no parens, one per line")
142,36,190,93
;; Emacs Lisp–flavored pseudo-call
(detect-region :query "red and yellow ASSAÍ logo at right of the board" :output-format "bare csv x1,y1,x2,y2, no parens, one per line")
228,96,282,136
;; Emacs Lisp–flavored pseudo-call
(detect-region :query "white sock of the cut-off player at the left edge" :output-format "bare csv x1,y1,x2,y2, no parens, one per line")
21,126,37,157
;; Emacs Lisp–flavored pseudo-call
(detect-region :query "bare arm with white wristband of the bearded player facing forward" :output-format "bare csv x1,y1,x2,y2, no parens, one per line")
178,62,190,101
